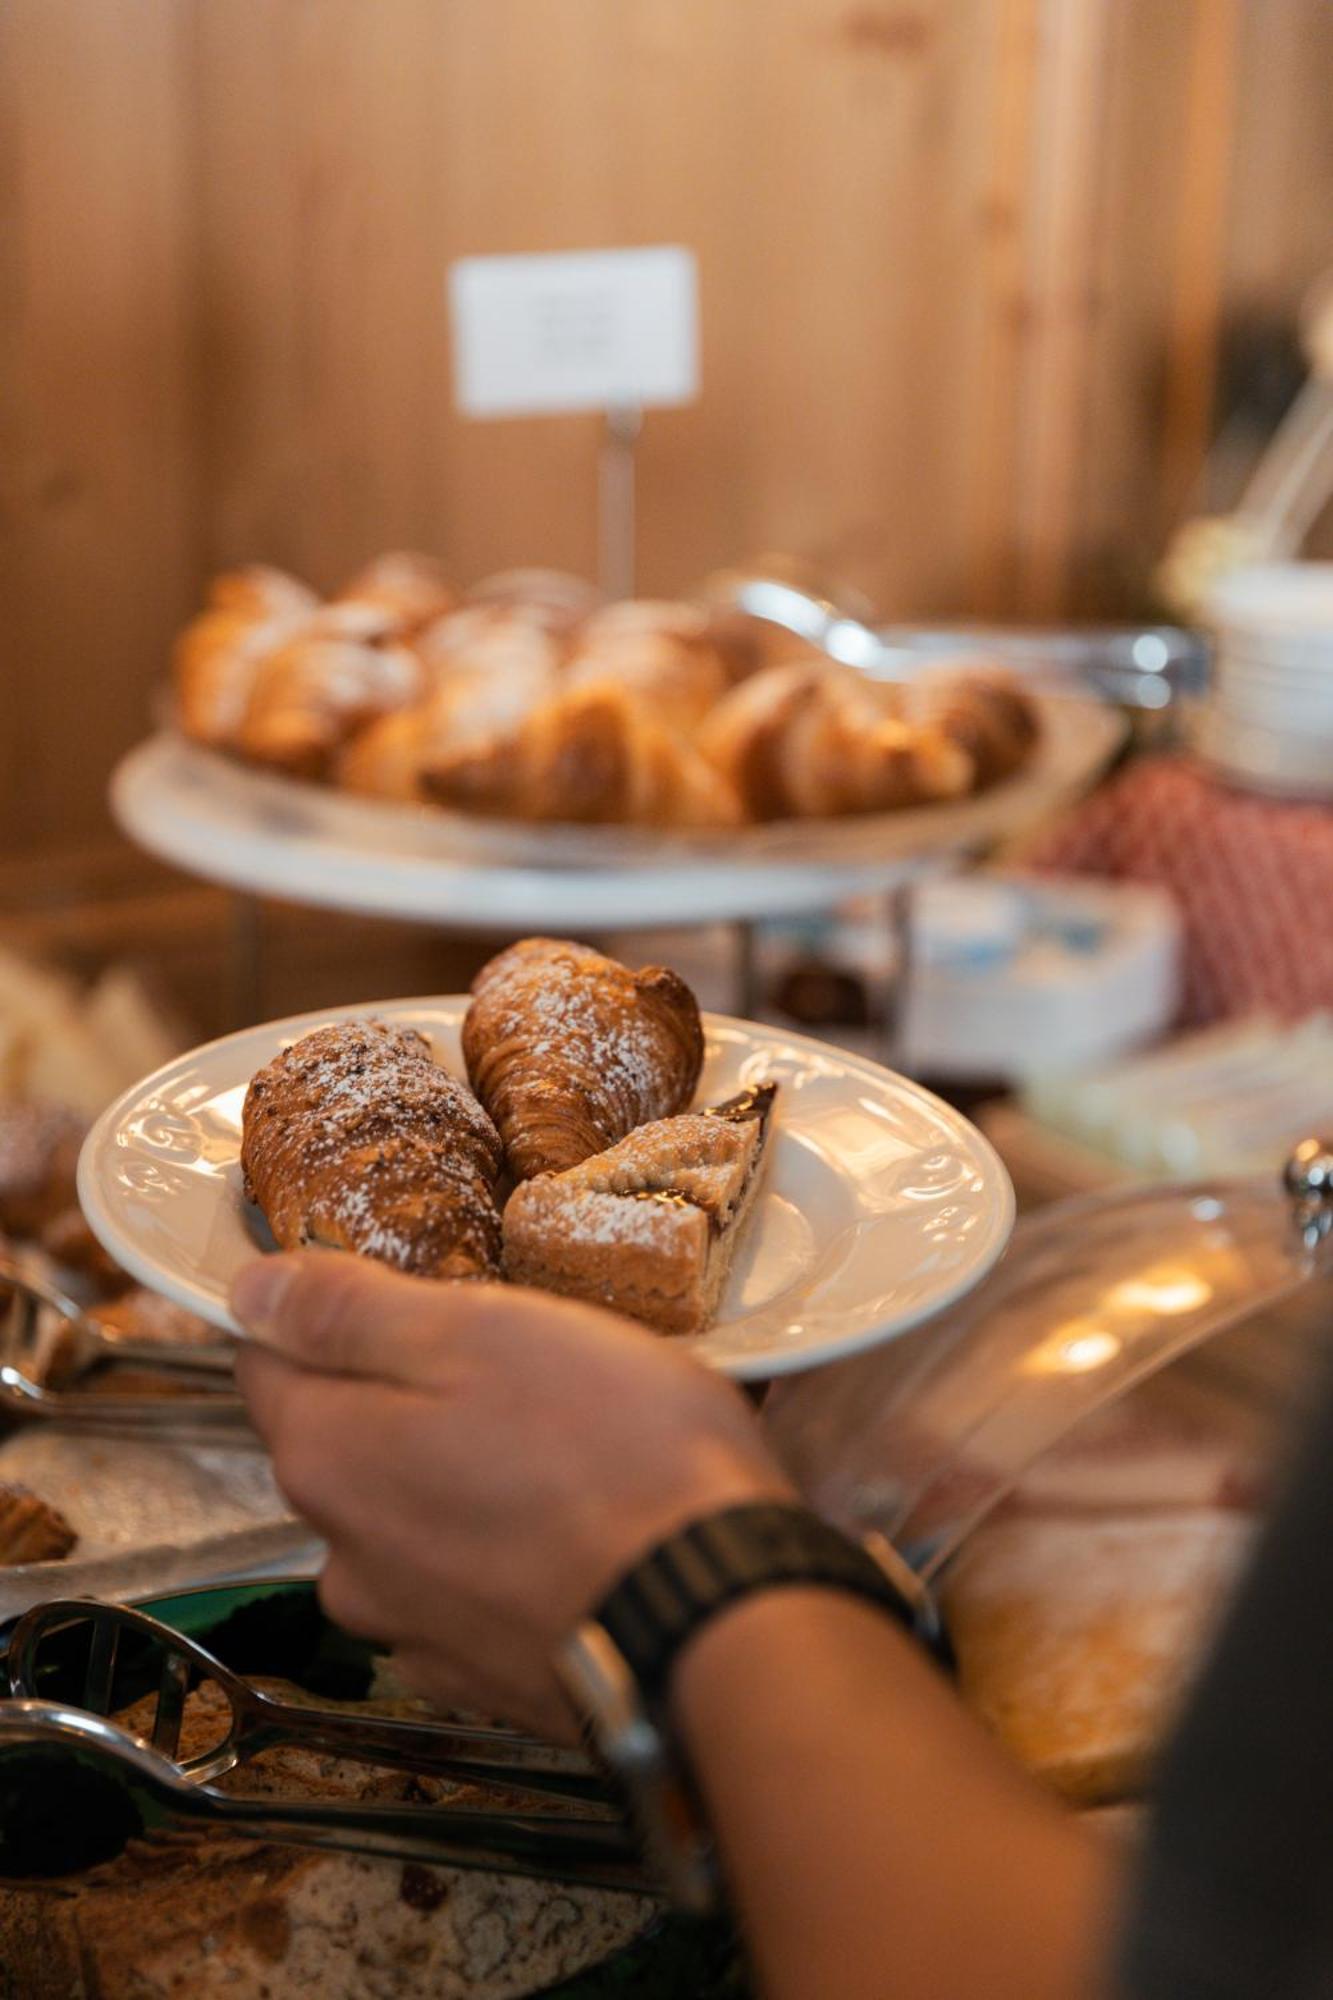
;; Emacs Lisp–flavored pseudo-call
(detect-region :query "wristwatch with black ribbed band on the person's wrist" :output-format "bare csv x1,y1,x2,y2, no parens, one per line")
556,1502,951,1914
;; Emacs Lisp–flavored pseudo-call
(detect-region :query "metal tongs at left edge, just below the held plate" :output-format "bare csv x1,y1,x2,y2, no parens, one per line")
0,1256,244,1434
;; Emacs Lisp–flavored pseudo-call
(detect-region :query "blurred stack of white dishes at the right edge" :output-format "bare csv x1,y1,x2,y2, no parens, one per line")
1195,562,1333,798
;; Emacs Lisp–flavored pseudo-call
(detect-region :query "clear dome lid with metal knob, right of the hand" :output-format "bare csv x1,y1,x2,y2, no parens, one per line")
765,1140,1333,1584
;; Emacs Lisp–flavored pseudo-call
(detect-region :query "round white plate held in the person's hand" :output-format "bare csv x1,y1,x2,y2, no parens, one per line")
78,996,1013,1380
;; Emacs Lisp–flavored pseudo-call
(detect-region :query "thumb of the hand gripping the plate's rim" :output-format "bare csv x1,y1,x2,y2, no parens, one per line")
232,1250,488,1386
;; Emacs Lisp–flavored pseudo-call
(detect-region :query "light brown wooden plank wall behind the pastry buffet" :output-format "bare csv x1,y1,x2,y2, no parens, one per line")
0,0,1333,852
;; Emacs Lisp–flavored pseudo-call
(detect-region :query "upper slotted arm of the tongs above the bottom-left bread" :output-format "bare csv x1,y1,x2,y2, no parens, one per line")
6,1598,610,1806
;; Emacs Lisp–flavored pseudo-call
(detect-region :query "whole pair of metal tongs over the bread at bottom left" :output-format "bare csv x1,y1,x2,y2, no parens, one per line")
0,1598,648,1890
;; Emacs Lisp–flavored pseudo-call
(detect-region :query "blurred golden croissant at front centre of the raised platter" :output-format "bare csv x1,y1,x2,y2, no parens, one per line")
420,682,741,826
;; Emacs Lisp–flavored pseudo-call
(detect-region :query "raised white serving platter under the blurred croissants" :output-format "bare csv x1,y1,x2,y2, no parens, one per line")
110,694,1125,932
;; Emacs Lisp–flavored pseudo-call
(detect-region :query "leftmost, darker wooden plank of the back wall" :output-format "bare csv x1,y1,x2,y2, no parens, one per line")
0,0,198,850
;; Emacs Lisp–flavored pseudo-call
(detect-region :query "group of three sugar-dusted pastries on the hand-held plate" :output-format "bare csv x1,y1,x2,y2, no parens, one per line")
240,938,777,1332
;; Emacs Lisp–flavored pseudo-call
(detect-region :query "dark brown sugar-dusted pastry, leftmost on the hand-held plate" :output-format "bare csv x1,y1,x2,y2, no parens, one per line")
240,1020,500,1278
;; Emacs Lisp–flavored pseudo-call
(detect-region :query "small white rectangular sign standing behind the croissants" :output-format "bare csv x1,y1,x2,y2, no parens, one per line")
448,244,699,416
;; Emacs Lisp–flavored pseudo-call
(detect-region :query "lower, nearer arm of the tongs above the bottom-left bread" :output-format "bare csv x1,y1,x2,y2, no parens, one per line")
0,1700,656,1894
